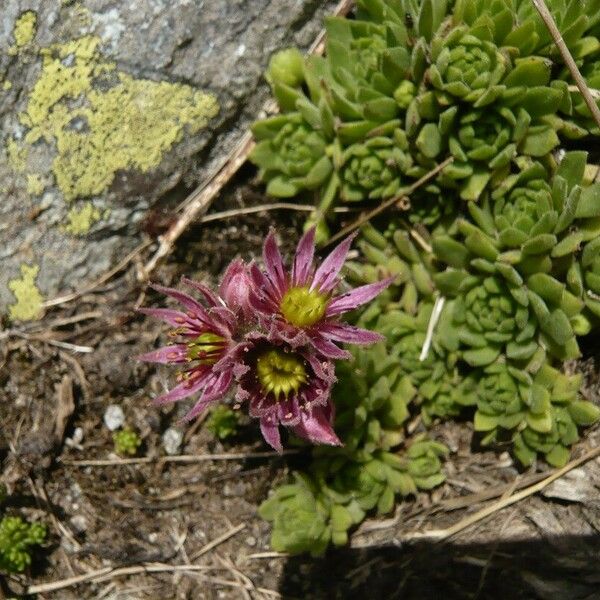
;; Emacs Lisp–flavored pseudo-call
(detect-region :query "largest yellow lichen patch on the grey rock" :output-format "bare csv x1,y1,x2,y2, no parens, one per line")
11,36,219,200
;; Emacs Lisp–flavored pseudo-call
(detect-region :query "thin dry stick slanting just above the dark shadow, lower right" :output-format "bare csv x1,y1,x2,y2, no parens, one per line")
401,446,600,541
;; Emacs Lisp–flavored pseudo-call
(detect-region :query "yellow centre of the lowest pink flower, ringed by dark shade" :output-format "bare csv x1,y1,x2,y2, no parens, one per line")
256,350,307,401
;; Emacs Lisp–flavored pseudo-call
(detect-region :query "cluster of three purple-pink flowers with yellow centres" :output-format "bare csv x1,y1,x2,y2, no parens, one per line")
140,229,389,451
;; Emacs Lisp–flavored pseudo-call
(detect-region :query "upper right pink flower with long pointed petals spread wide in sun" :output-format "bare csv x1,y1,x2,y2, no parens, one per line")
250,228,393,359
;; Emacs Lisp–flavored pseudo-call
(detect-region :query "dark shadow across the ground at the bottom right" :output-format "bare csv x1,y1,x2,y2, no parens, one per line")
279,535,600,600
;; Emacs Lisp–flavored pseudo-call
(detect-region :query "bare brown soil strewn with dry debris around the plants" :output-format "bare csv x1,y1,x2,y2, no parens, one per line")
0,170,600,600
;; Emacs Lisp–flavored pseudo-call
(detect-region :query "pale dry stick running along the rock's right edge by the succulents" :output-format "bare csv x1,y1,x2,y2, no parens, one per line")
142,0,352,280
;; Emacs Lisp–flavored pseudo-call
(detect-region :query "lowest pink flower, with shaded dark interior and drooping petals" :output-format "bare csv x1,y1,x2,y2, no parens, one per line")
229,333,341,452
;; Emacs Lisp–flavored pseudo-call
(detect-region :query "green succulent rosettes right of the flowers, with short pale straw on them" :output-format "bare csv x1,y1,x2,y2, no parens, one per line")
348,146,600,466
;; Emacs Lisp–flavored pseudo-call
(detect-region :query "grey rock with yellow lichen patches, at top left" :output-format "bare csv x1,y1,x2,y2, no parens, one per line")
0,0,336,321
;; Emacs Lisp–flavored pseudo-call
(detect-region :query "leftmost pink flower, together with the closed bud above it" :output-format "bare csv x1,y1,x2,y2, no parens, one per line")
138,261,249,420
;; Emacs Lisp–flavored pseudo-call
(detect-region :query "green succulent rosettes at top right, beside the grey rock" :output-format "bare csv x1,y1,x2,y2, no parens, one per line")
251,0,600,238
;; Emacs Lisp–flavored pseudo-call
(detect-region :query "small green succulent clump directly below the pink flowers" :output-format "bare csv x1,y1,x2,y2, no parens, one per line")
259,343,447,555
